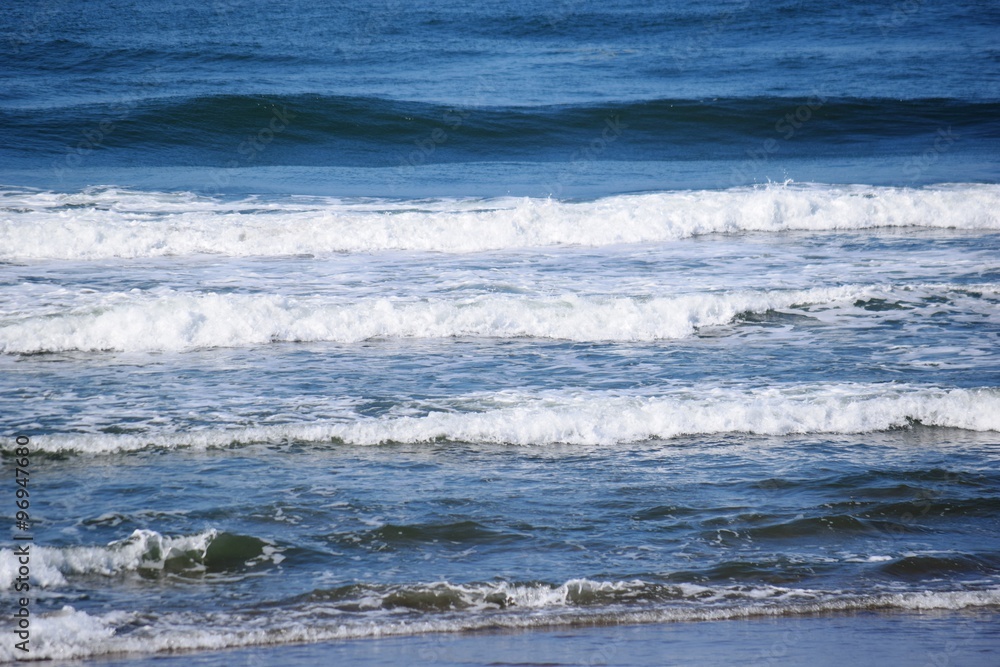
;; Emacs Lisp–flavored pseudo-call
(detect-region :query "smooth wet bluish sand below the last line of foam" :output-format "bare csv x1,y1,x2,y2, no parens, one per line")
80,610,1000,667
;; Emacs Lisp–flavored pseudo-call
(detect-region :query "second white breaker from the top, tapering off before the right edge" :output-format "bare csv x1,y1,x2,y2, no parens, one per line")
0,287,871,354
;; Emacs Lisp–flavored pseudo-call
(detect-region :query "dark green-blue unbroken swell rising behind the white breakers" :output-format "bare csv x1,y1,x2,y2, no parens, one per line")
0,94,1000,167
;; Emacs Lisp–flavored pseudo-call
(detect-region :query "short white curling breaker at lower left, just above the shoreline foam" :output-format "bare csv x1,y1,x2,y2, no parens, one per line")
0,529,283,588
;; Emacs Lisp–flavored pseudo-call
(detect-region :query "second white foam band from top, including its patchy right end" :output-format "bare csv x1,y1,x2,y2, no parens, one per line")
0,283,1000,354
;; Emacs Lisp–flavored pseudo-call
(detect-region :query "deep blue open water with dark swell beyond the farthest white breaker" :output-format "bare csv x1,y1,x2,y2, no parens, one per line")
0,1,1000,196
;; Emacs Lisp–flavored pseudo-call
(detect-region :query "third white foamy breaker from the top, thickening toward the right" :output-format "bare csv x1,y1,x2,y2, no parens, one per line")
23,384,1000,454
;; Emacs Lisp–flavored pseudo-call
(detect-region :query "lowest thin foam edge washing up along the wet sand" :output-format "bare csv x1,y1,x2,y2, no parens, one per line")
0,580,1000,662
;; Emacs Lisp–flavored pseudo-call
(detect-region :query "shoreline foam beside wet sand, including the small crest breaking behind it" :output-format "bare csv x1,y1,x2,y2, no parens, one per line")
0,579,1000,662
